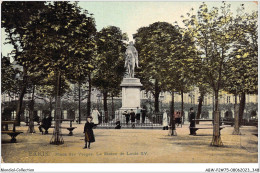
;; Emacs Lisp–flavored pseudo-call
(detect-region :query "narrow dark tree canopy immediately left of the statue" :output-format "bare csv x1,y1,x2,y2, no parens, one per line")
93,26,127,96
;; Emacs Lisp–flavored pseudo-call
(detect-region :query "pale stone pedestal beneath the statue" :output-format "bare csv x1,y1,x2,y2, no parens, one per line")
120,78,143,110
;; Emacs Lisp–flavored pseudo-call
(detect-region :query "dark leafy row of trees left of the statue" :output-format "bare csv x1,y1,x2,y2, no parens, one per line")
2,2,127,137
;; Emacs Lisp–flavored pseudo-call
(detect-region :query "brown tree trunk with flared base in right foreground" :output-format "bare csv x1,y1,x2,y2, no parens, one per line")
211,90,223,146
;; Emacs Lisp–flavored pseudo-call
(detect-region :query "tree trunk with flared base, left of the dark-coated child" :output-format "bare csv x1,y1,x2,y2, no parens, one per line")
50,71,64,145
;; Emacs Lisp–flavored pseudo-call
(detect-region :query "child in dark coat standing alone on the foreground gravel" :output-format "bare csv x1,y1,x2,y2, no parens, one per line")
83,116,95,149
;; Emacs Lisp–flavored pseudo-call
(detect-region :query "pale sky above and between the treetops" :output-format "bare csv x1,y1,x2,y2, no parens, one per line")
1,1,258,56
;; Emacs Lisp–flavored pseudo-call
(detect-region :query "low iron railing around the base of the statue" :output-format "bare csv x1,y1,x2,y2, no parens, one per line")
98,111,163,128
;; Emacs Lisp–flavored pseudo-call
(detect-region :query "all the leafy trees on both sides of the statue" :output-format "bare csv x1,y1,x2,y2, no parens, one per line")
2,2,258,145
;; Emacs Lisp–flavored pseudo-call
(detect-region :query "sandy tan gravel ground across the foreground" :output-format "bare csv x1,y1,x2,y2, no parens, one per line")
2,124,258,163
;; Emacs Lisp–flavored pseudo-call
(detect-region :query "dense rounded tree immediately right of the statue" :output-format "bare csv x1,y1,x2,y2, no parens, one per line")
134,22,181,112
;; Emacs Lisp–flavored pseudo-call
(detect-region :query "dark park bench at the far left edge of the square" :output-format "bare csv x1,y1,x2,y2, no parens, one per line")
1,121,23,143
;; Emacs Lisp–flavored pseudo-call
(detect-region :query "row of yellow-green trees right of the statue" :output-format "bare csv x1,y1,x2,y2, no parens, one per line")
134,2,258,146
